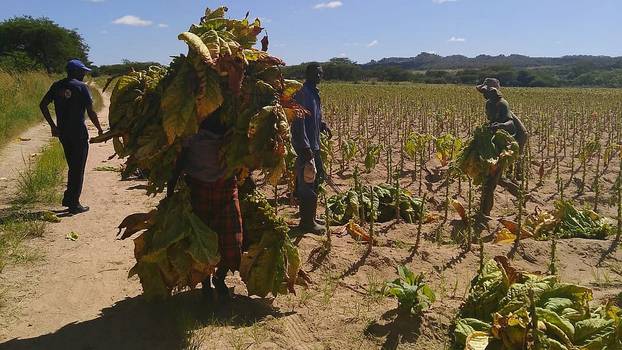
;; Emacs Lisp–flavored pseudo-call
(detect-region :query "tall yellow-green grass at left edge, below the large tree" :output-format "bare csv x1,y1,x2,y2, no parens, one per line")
0,71,54,146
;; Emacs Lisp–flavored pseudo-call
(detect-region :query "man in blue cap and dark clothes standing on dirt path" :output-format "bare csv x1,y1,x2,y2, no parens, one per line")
39,59,103,214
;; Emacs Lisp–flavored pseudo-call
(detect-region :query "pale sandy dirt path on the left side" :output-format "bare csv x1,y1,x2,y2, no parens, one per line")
0,91,178,349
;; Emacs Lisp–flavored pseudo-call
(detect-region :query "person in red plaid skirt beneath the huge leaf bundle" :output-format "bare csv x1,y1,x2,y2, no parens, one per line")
166,115,243,300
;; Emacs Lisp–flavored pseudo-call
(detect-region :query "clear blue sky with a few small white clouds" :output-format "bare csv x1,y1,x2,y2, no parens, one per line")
0,0,622,65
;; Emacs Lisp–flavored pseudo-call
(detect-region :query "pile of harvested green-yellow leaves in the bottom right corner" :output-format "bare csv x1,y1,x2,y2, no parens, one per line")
454,257,622,350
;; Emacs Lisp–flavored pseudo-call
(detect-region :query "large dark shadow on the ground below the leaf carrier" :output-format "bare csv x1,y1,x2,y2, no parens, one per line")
0,290,283,350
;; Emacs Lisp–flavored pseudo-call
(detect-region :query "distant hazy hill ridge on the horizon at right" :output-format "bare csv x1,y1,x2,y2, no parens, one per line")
364,52,622,70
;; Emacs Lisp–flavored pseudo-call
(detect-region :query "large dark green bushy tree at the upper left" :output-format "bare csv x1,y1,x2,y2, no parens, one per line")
0,16,90,73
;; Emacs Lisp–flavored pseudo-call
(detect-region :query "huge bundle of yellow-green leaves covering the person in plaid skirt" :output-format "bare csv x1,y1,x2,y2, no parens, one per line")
94,7,304,297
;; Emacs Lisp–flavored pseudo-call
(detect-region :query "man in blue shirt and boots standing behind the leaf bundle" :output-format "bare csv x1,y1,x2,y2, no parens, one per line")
291,63,331,234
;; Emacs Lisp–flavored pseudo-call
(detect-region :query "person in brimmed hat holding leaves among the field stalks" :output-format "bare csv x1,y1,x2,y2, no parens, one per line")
476,78,527,217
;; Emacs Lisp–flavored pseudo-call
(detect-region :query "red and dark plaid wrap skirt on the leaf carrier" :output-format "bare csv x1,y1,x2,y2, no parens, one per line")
186,176,243,272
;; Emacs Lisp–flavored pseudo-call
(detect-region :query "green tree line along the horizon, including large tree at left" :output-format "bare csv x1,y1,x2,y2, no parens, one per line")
0,16,622,87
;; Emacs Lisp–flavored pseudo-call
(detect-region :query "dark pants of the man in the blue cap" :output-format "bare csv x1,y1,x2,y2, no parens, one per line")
60,135,89,208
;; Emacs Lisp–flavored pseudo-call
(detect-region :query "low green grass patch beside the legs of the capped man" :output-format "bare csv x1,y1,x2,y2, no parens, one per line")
14,140,67,205
